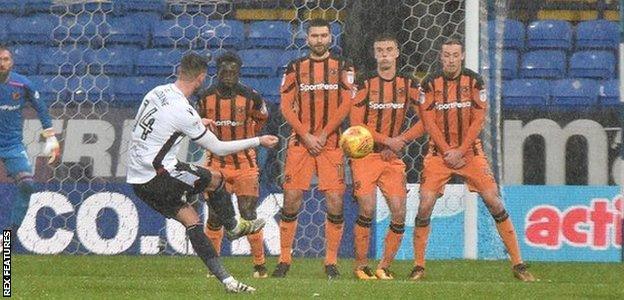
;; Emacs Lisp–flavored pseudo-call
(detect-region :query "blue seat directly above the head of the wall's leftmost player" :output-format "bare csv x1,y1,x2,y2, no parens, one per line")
199,20,245,49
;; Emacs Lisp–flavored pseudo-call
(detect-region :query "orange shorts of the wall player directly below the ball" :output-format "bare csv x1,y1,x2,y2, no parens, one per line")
350,153,407,197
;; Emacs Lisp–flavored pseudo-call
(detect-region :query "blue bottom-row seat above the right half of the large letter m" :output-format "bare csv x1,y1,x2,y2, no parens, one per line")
552,79,600,107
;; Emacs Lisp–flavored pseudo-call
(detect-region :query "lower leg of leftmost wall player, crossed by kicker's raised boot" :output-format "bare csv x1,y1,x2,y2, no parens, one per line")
238,196,269,278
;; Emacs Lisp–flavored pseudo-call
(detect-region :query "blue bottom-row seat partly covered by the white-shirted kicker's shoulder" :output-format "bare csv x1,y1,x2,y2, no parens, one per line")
112,76,168,106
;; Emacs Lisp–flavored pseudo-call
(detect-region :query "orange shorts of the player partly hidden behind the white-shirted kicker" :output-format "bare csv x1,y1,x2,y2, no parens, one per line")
211,165,260,198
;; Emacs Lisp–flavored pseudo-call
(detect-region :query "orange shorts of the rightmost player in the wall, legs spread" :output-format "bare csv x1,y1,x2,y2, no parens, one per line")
420,154,498,194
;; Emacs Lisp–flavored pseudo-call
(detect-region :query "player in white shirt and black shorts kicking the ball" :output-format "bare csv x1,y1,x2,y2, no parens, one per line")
126,53,278,293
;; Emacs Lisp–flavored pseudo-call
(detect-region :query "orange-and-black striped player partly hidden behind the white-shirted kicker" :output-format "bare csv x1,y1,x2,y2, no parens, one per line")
198,52,269,278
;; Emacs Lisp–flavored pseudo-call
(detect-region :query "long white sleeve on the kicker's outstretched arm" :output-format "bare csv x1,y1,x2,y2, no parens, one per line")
176,106,260,156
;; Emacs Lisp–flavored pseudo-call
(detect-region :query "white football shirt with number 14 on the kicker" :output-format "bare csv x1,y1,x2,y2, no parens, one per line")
126,84,208,184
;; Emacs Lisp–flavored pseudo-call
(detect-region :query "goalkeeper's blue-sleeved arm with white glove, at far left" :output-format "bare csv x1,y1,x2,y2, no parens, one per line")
27,84,61,164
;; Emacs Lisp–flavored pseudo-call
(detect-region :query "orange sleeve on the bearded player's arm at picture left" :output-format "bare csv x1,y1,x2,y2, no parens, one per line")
280,63,308,136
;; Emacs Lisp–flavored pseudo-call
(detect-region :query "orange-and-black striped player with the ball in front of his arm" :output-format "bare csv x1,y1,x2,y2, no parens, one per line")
350,34,424,280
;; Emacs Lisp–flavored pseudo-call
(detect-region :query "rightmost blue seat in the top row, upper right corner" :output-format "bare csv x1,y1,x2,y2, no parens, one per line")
576,20,620,50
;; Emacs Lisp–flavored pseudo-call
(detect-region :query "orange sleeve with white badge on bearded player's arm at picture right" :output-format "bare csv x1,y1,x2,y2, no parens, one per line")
323,62,356,134
